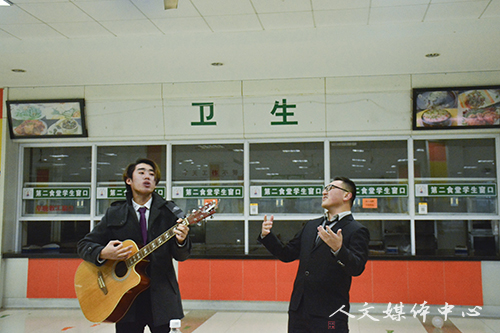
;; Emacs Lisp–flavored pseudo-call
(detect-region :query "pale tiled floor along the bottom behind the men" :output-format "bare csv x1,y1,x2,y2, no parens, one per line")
0,309,500,333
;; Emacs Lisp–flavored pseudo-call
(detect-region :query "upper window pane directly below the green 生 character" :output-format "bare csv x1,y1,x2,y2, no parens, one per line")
250,142,325,214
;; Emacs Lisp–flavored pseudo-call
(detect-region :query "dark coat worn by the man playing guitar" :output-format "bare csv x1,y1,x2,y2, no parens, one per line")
77,193,191,326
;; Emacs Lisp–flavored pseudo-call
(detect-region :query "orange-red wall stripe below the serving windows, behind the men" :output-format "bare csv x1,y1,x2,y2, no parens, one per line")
27,259,483,306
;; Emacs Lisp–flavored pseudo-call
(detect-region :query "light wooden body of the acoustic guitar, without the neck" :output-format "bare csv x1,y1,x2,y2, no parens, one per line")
75,240,149,323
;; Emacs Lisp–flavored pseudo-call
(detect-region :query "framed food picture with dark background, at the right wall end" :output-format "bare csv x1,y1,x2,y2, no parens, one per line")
413,86,500,130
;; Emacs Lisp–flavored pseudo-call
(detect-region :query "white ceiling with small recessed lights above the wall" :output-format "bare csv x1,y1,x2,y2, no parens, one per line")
0,0,500,87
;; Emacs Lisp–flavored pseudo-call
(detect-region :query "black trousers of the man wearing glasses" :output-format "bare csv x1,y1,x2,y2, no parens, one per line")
288,303,349,333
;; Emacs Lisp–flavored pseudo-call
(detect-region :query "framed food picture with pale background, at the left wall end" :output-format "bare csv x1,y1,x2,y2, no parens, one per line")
6,99,87,139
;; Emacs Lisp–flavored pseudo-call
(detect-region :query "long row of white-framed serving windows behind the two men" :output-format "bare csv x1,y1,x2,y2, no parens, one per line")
8,136,500,258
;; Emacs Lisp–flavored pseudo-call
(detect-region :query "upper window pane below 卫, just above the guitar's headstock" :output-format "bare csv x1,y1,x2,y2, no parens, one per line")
172,144,244,214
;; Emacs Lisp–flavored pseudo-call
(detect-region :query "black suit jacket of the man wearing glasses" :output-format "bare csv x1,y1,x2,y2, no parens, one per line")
259,215,370,321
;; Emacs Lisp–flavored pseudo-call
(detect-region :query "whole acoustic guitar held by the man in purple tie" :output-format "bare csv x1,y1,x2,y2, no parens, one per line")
75,201,217,323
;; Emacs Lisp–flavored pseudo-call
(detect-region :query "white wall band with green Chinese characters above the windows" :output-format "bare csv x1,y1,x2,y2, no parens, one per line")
6,72,500,142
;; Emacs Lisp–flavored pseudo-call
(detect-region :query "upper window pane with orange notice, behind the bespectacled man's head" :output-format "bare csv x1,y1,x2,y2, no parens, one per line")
330,140,408,213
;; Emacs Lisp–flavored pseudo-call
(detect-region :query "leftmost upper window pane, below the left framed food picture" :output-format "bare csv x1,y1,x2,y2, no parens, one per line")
22,147,91,216
